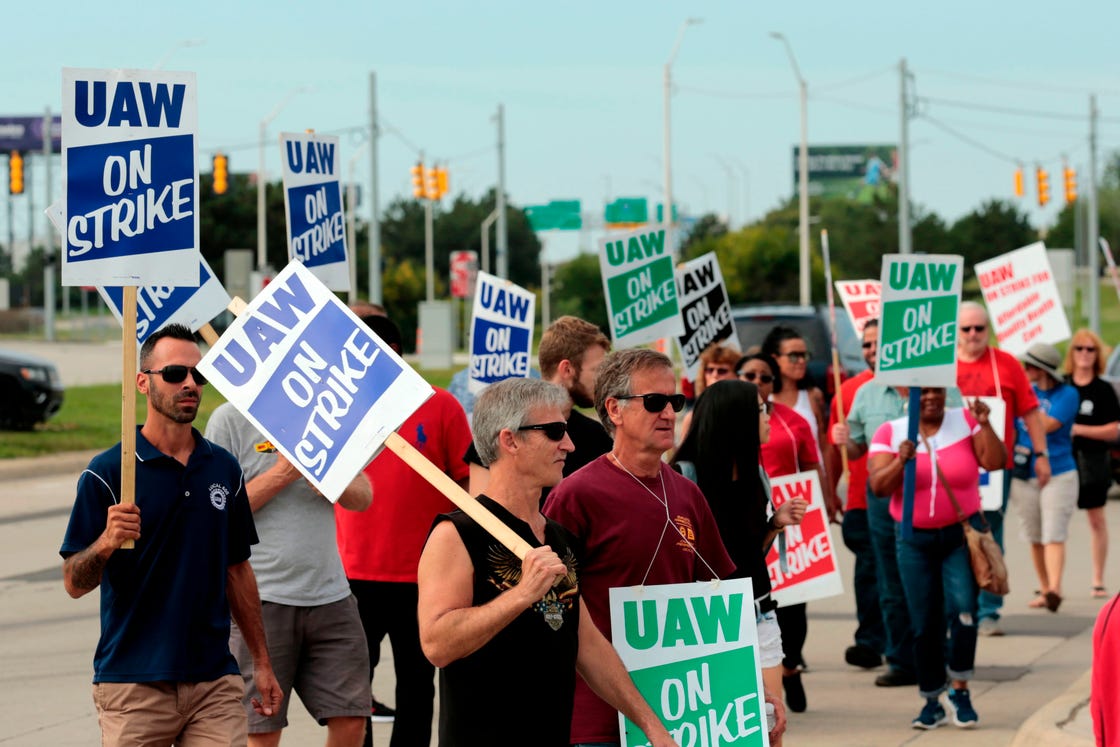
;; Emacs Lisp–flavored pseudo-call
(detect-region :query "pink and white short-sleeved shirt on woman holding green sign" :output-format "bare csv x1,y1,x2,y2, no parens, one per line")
868,408,980,529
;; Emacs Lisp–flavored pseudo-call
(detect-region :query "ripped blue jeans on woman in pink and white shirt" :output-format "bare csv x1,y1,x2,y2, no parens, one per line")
896,516,979,698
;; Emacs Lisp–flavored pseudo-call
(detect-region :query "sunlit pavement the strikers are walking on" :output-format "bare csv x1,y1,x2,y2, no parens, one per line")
0,447,1102,747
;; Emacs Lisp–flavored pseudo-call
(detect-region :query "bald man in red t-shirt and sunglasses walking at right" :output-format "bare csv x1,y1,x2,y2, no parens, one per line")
956,301,1051,635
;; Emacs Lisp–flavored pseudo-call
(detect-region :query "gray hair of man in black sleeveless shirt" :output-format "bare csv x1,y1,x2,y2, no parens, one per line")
470,377,571,466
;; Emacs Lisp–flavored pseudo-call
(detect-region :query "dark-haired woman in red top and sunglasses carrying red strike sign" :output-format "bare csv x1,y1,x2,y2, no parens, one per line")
735,353,825,713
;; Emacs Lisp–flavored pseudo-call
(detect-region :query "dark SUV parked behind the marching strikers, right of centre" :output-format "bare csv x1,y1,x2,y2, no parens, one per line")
731,304,867,400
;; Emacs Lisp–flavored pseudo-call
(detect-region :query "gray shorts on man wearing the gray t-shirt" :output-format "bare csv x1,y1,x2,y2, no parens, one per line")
230,595,370,734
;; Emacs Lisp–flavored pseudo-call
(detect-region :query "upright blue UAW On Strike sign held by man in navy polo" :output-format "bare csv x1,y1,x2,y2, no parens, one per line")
62,68,199,287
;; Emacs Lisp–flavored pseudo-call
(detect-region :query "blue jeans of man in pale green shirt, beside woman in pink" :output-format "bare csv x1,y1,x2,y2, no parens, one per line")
867,488,914,672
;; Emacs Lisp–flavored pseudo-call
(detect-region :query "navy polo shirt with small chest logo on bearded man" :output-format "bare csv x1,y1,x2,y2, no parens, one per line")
59,428,258,682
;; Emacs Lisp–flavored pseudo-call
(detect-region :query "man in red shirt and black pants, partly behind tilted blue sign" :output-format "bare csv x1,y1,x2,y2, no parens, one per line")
335,315,470,747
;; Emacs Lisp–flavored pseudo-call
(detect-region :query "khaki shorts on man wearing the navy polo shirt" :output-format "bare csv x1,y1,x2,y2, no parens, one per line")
93,674,248,747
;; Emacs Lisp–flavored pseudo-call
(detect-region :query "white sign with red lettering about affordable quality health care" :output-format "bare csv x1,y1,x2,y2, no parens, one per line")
973,242,1071,356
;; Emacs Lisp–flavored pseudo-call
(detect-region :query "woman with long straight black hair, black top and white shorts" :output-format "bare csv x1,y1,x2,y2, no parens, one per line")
673,381,806,745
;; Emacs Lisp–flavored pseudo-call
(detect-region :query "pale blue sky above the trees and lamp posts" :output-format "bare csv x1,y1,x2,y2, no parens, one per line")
0,0,1120,268
